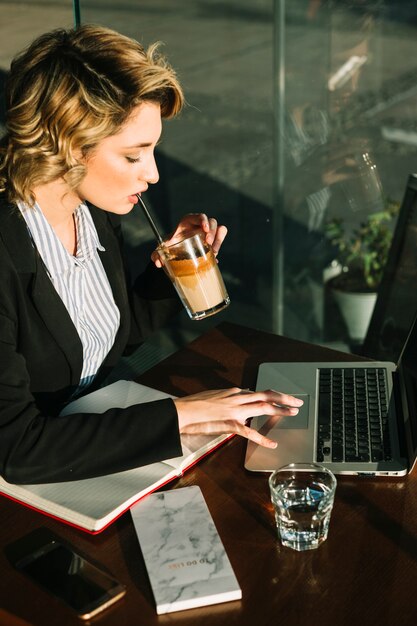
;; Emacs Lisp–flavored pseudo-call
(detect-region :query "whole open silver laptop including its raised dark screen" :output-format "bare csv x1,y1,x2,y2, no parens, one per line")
245,175,417,476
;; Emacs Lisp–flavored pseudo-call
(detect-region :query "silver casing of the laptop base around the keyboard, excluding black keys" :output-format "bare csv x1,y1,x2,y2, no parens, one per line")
245,312,417,476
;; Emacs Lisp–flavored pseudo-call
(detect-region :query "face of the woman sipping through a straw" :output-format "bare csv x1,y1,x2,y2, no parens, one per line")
77,102,162,214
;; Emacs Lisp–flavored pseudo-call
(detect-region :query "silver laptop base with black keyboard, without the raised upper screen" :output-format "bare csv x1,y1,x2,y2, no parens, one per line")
245,321,417,476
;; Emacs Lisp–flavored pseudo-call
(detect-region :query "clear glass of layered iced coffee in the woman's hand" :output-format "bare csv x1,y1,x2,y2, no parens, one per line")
158,231,230,320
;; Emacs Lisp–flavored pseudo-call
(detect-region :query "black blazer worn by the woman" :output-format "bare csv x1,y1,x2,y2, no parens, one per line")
0,197,181,483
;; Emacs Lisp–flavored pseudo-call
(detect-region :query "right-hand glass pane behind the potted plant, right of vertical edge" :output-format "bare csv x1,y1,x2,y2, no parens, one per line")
276,0,417,350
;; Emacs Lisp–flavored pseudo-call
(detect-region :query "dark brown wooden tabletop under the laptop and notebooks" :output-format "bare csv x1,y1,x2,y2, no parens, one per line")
0,323,417,626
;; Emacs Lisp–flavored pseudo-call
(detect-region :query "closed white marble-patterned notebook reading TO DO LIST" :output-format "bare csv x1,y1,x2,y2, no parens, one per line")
131,486,242,615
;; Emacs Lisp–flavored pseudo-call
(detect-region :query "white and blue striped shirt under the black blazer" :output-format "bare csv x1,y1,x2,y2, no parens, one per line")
18,203,120,393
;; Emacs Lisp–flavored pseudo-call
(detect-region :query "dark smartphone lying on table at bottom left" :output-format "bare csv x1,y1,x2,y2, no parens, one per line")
6,529,126,620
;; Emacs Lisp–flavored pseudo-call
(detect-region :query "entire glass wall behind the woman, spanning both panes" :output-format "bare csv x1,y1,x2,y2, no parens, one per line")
0,0,417,349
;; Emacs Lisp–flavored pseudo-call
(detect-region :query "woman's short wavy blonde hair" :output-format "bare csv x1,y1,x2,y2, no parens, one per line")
0,25,184,205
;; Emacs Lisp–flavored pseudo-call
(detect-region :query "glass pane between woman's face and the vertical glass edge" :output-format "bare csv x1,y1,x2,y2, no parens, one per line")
77,0,274,333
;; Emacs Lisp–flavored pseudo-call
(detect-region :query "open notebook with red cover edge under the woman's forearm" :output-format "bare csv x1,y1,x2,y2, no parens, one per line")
0,380,233,534
